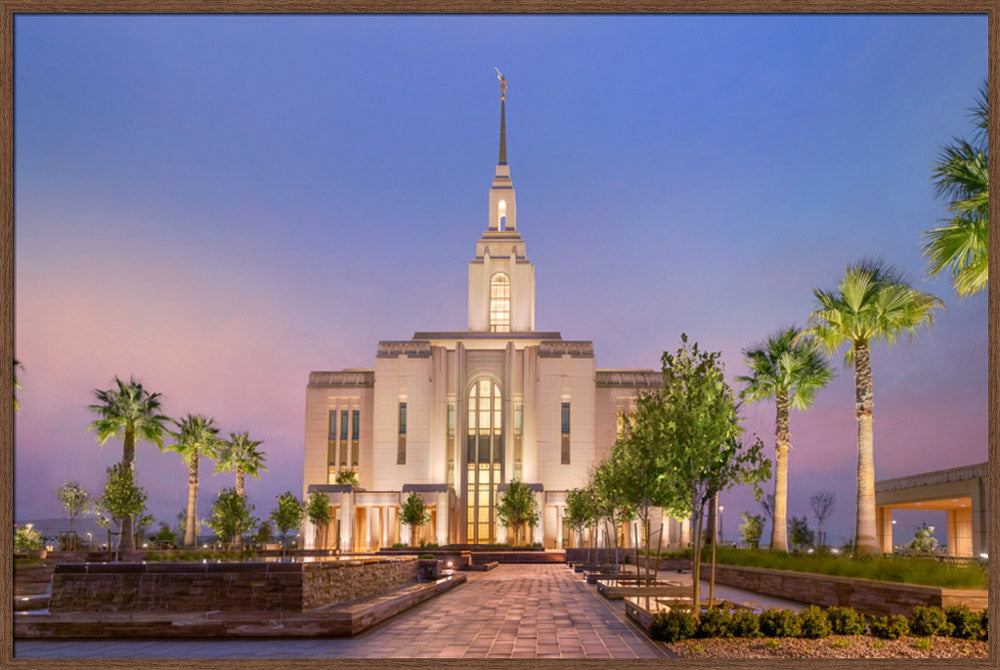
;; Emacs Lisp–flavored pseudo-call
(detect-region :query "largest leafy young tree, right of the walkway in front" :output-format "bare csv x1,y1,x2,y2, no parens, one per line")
636,334,771,608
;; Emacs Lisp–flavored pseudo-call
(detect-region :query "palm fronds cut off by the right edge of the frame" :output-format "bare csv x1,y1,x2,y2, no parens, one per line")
922,84,989,296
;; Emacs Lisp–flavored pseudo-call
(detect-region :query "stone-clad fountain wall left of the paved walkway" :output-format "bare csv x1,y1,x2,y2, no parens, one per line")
49,558,416,613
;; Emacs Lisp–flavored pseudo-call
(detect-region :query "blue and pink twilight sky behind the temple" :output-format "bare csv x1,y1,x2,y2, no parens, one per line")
14,15,987,544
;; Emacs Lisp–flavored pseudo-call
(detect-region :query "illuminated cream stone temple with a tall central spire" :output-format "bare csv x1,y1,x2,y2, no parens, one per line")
302,79,687,551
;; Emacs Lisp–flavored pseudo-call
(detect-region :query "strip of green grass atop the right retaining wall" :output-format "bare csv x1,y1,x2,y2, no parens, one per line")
717,547,987,589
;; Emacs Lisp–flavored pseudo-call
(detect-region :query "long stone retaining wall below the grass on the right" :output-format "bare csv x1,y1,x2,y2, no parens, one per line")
701,563,988,616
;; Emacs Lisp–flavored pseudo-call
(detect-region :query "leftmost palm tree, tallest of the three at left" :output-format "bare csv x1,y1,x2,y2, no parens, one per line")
87,377,170,552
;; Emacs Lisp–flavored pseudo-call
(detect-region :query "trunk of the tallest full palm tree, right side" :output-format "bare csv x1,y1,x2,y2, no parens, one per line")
854,340,881,554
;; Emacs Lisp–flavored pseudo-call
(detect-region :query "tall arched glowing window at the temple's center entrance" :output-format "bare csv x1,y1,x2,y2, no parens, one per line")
465,377,503,544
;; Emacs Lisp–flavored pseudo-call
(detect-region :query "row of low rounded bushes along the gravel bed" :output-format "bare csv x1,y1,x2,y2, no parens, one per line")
649,605,988,642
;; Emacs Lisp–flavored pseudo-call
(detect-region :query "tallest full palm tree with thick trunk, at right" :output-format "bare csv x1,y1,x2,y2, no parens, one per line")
803,259,943,554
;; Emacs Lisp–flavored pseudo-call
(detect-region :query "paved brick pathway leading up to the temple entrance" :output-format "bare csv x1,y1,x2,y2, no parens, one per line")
14,564,668,658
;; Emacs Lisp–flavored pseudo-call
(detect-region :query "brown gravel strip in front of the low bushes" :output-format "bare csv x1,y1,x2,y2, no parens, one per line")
666,635,989,658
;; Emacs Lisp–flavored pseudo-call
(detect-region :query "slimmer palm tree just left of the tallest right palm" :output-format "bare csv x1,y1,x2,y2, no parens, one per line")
736,326,833,551
